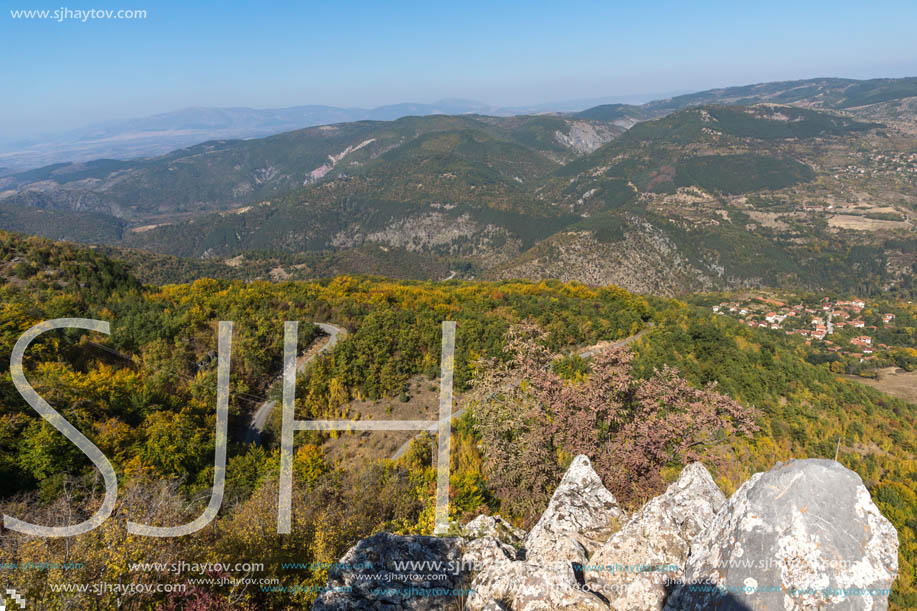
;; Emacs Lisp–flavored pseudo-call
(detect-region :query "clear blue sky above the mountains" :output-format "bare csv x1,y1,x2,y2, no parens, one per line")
0,0,917,139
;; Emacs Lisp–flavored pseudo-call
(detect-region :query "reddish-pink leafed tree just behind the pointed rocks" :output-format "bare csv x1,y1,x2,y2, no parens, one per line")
474,325,758,517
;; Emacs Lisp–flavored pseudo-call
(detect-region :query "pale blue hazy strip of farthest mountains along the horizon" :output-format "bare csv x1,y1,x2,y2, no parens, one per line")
0,78,917,175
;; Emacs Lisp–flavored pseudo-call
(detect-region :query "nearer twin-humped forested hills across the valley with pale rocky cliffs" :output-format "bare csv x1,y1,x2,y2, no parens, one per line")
104,106,917,294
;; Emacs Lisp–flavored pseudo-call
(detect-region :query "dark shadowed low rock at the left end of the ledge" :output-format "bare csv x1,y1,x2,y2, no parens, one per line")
312,533,470,611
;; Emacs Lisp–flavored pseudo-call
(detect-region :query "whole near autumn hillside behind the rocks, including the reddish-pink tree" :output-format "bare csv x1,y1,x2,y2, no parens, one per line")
0,233,917,609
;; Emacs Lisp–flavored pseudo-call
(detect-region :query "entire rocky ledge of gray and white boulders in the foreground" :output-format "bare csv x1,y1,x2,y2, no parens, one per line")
312,456,898,611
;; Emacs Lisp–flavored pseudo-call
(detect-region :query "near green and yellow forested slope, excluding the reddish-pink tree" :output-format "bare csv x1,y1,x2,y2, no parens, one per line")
0,233,917,609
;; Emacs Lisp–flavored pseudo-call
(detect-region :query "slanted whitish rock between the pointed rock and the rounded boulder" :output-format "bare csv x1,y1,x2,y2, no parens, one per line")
584,463,726,611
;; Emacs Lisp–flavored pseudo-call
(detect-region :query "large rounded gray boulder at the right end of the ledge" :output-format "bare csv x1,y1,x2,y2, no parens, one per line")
665,459,898,611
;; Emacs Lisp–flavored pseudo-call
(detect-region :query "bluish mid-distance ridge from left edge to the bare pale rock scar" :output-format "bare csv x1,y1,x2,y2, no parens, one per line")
0,115,622,223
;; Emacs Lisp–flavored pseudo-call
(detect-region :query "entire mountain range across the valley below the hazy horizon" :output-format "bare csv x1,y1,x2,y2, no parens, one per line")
0,78,917,295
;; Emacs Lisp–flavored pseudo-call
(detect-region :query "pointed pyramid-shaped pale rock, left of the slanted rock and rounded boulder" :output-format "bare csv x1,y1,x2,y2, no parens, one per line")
525,454,624,564
